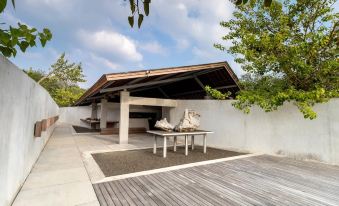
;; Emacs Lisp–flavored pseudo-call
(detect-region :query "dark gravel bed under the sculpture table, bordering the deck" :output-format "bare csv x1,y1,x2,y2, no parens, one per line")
92,146,245,177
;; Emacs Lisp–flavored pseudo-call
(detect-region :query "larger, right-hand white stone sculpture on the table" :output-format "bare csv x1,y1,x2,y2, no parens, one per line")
174,109,200,132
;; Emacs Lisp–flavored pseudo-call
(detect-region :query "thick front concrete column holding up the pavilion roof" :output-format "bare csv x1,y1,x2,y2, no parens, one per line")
119,91,129,144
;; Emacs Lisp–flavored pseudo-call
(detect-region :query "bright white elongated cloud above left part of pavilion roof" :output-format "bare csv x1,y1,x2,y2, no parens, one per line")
79,30,142,61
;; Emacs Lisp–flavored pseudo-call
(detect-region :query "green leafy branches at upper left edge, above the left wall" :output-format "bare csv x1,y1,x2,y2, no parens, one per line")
0,0,52,57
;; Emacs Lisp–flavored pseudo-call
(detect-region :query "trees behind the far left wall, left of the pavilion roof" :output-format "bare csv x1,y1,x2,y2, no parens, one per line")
25,53,85,106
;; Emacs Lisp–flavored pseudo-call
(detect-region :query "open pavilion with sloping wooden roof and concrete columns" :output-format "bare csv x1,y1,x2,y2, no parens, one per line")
75,62,239,144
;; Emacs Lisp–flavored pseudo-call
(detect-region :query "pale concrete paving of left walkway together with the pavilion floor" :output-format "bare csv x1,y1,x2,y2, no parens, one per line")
13,123,165,206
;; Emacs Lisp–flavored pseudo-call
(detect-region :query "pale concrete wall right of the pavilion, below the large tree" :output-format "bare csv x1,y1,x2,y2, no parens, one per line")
169,99,339,164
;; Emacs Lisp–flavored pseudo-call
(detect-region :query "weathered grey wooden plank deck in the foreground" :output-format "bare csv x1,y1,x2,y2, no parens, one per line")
93,155,339,206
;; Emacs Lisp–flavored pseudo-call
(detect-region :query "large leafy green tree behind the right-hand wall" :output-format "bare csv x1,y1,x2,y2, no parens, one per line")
211,0,339,119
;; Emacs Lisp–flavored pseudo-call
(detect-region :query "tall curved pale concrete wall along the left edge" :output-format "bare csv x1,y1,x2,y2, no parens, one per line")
0,55,58,205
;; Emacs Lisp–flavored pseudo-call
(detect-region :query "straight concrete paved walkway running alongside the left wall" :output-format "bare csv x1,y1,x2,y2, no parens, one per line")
13,125,104,206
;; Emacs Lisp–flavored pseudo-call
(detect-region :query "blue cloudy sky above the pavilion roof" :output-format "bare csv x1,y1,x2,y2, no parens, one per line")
0,0,242,88
